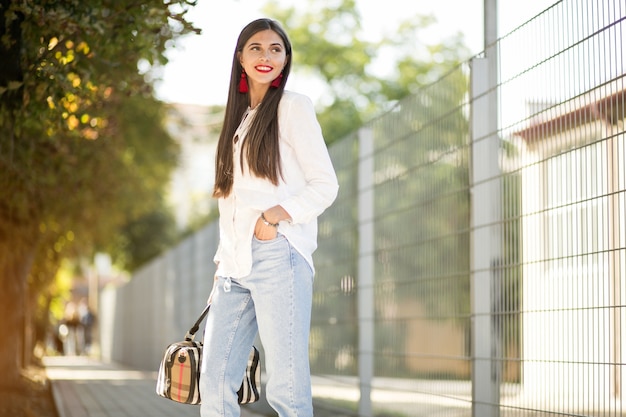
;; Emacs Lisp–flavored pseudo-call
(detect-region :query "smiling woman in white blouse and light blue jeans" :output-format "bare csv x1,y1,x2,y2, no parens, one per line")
200,19,338,417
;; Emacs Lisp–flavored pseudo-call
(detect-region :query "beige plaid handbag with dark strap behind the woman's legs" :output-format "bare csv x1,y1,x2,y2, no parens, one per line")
156,304,261,404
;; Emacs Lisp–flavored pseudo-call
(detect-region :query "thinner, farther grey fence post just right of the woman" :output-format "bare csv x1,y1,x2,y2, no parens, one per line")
357,128,375,417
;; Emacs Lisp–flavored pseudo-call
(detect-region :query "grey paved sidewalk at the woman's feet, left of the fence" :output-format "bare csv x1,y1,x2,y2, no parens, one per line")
44,356,263,417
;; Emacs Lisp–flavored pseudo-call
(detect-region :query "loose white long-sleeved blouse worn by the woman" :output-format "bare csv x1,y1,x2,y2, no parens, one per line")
214,91,339,278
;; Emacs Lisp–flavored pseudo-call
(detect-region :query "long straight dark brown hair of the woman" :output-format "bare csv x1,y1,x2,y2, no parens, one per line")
213,18,292,197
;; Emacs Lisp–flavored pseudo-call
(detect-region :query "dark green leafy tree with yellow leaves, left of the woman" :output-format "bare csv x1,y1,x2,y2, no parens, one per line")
0,0,194,387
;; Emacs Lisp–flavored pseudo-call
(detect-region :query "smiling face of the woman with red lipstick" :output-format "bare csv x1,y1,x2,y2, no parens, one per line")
239,29,288,89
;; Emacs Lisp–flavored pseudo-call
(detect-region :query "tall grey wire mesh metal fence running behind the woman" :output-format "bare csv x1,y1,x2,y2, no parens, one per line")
101,0,626,417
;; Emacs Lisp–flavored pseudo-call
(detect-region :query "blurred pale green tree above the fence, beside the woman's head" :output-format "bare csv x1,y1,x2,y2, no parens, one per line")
264,0,469,143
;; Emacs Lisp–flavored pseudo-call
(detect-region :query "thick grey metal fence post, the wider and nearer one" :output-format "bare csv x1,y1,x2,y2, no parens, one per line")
470,53,501,417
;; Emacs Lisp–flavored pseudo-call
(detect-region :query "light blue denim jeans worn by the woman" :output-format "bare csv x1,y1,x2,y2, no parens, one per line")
200,234,313,417
